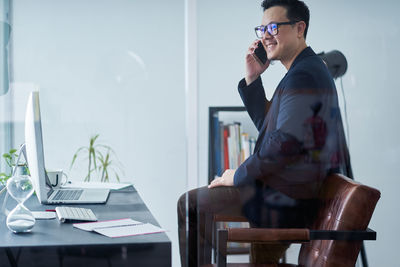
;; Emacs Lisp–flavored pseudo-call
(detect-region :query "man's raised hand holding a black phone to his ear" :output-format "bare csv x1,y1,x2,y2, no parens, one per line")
245,40,270,85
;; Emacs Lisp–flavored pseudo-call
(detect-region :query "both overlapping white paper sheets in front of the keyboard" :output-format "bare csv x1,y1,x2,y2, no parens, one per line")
73,218,165,237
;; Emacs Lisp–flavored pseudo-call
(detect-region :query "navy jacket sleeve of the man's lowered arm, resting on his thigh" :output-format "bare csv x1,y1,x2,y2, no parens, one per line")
234,74,318,186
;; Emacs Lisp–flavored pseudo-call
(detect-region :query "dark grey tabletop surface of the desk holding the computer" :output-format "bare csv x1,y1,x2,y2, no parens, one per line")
0,187,171,266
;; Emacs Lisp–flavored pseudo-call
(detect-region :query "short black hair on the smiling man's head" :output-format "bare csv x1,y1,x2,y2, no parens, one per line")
261,0,310,39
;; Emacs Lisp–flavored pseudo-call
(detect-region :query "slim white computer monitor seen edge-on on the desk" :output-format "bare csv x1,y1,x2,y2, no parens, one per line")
25,91,51,203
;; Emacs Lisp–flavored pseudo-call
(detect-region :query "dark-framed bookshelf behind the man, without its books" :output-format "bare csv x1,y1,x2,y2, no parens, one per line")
208,106,258,183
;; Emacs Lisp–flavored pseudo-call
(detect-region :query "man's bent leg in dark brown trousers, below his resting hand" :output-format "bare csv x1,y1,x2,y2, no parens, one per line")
178,187,242,267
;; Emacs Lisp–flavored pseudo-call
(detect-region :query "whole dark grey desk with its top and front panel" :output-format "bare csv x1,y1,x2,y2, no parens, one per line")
0,187,171,267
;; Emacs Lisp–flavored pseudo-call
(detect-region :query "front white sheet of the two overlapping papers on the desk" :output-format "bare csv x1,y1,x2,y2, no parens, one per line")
94,223,165,237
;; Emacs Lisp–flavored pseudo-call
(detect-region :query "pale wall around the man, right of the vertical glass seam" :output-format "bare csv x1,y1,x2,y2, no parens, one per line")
198,0,400,266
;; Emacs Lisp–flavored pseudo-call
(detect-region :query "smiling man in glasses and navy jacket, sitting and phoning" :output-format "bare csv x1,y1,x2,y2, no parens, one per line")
178,0,348,266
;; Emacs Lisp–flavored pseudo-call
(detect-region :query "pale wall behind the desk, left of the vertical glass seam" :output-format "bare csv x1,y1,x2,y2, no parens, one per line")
13,0,186,266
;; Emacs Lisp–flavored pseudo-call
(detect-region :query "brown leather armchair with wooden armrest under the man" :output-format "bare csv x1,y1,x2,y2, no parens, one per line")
209,174,380,267
